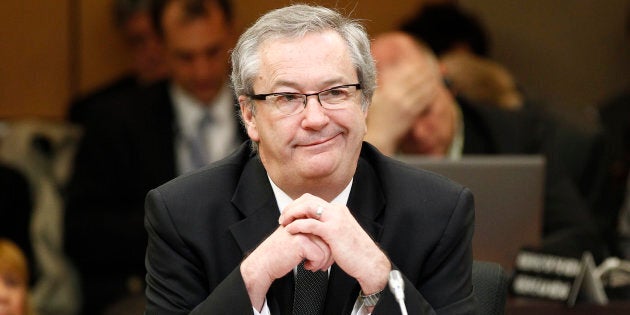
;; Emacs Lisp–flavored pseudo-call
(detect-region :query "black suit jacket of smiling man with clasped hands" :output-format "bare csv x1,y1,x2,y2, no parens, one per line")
145,144,475,314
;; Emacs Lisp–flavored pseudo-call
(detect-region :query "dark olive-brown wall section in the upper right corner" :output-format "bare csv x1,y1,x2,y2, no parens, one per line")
459,0,630,120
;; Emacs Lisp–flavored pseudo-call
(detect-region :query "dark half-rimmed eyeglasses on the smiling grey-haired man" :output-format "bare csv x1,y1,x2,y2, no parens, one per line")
249,83,361,116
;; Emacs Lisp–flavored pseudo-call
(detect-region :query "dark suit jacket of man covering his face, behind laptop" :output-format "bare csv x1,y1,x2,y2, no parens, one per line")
458,99,608,261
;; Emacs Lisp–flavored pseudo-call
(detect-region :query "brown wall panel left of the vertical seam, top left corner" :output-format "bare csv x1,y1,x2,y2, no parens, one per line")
0,0,70,118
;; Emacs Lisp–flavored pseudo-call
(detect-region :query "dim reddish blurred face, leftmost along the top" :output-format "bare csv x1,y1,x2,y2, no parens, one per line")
122,12,168,84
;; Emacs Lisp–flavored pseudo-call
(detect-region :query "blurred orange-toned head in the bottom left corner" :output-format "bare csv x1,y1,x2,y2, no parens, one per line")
0,238,30,315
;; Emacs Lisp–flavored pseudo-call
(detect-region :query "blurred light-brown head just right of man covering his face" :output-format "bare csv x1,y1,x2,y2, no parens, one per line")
440,52,523,110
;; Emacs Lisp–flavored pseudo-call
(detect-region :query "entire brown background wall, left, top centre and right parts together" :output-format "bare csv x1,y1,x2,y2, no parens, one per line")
0,0,630,119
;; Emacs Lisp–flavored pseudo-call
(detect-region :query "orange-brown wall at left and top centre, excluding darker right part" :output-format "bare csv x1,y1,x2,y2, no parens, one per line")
0,0,424,119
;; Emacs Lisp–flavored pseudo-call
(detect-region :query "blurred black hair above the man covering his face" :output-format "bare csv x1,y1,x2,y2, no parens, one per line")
401,3,489,56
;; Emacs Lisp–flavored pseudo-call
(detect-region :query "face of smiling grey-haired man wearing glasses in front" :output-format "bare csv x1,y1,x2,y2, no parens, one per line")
239,31,366,193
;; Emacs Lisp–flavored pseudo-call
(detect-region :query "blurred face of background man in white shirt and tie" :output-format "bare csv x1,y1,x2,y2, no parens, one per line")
162,1,232,103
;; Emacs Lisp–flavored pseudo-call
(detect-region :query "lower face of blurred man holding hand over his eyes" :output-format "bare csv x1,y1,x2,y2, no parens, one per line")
401,85,457,156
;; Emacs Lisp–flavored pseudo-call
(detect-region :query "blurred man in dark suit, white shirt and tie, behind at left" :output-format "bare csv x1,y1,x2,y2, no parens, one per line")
65,0,245,314
